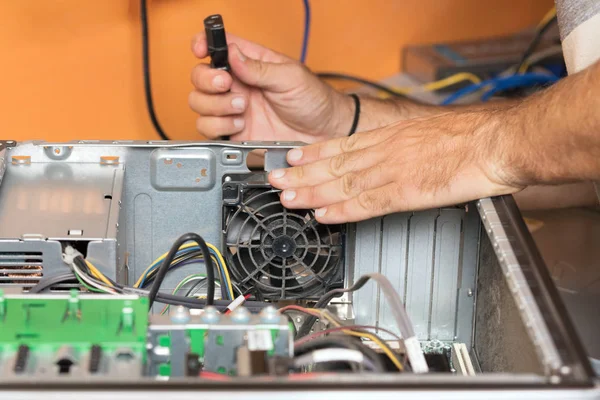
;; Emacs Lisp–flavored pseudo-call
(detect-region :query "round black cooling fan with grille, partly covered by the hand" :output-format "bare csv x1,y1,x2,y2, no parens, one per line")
223,177,343,300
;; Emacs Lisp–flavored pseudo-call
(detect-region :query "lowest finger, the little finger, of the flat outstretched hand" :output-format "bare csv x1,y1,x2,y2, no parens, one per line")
315,182,401,224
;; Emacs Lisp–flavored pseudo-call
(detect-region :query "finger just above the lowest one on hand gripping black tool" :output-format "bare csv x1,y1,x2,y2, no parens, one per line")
188,91,248,117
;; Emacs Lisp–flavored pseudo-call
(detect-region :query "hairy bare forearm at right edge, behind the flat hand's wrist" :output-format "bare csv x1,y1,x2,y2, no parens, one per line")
490,62,600,186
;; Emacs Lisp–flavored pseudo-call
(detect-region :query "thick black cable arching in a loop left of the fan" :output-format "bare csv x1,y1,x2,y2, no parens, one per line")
148,233,215,309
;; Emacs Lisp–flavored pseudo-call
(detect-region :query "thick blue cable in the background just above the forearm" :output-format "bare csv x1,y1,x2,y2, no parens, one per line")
441,73,559,106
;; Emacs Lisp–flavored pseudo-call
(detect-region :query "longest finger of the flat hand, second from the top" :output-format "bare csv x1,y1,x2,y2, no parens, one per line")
269,145,386,189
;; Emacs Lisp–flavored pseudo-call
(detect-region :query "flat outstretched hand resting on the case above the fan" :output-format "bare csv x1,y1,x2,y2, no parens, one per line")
269,112,524,224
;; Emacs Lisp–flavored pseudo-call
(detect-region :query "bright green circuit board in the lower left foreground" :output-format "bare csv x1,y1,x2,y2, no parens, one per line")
0,290,148,355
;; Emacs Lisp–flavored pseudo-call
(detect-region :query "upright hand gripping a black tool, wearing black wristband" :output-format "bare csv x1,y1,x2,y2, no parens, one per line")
189,32,354,143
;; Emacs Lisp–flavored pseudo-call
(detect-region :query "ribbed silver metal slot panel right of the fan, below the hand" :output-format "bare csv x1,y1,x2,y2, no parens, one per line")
348,207,479,346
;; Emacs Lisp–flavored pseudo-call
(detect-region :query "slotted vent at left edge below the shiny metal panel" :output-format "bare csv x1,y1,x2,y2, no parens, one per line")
0,251,44,286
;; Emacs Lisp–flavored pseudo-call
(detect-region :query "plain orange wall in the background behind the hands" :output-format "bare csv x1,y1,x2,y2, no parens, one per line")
0,0,552,140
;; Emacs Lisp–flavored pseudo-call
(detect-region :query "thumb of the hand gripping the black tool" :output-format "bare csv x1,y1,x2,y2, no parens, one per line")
229,44,303,92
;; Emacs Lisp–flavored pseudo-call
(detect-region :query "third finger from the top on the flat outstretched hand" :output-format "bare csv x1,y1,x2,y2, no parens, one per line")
281,164,393,209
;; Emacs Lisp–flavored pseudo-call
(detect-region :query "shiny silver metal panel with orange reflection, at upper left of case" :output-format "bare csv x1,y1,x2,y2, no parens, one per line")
0,162,123,240
